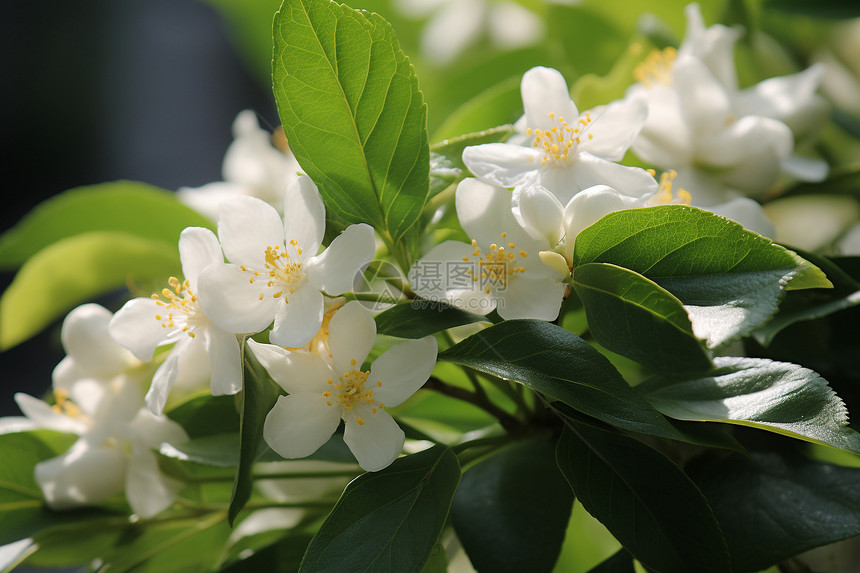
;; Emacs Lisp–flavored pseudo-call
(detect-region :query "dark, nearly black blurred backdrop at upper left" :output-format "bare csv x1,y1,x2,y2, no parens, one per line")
0,0,279,415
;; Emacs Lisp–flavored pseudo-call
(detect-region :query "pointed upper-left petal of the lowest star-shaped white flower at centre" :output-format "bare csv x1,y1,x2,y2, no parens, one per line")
248,340,333,394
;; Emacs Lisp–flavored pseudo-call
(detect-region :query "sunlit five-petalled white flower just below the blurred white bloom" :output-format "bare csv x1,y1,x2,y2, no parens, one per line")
200,176,375,348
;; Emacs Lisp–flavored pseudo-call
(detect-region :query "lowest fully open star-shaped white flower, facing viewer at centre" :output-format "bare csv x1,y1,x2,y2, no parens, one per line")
248,301,437,471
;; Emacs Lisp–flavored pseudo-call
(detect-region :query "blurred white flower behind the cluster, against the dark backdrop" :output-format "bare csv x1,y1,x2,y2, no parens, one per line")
176,109,301,220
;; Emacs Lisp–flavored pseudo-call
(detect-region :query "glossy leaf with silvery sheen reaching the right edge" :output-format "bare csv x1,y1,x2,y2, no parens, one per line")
637,356,860,453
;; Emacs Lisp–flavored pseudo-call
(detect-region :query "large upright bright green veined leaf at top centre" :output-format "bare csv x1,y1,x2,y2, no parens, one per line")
272,0,430,244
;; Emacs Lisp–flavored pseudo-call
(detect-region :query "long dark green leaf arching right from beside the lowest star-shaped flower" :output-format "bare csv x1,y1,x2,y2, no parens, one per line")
439,320,686,440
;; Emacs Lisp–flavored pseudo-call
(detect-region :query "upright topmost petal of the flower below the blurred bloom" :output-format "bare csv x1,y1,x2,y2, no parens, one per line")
284,175,326,256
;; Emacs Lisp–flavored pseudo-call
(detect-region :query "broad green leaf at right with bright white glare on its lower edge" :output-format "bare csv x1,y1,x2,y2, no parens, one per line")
573,205,832,348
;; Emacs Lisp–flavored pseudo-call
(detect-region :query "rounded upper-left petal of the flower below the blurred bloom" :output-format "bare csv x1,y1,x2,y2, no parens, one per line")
218,197,284,269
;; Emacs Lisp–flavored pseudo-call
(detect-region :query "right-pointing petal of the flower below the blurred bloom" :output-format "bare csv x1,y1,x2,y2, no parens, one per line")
306,223,376,295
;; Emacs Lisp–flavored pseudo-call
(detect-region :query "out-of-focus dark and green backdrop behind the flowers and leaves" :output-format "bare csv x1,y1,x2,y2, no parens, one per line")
0,0,860,415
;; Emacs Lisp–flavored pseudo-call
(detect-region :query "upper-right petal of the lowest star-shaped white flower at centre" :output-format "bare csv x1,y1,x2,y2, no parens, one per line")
367,336,438,407
